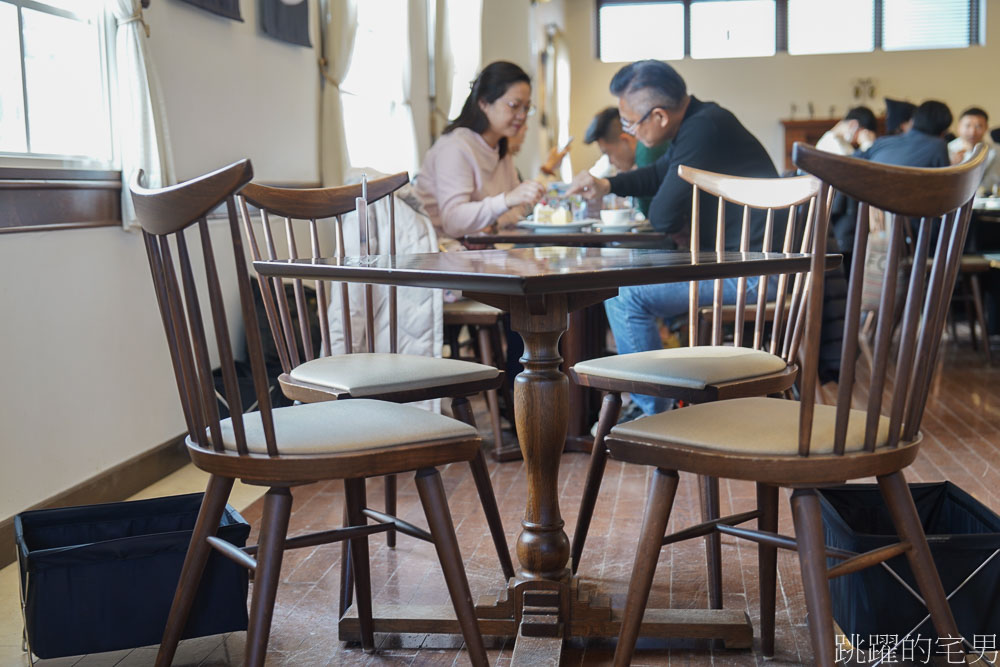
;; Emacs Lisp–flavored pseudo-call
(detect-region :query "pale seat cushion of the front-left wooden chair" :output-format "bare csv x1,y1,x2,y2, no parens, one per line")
222,399,479,454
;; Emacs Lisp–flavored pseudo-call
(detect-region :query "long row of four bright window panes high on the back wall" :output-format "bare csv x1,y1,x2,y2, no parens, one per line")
597,0,985,62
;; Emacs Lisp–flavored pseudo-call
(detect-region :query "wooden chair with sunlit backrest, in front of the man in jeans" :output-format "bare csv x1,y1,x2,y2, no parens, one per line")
570,166,820,608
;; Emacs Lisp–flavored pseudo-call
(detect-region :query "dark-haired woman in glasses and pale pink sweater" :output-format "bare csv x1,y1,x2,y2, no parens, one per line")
416,61,545,248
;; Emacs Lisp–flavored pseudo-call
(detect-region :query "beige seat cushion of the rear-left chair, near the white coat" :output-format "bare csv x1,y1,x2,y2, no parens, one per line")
290,352,500,397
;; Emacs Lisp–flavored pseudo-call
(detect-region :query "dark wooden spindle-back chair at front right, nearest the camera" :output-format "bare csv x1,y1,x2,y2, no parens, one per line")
605,144,985,667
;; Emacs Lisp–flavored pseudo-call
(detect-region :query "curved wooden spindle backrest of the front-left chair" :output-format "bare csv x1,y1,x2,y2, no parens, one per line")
131,160,278,456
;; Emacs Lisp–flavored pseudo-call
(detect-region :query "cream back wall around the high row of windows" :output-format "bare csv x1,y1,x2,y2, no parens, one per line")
566,0,1000,175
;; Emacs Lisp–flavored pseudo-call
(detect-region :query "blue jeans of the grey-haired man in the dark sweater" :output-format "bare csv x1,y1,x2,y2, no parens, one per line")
604,277,777,415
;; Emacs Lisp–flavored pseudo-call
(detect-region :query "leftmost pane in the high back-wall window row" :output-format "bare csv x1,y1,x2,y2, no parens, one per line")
597,2,684,63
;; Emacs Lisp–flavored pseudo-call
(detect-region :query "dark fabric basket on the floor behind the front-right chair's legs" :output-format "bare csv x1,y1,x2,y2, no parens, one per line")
820,482,1000,642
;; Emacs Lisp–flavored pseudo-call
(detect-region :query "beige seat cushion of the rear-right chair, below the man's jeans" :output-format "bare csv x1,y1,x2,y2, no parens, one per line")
573,345,786,389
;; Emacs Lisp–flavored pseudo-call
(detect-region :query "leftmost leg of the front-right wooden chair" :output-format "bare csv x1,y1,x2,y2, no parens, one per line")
615,468,678,667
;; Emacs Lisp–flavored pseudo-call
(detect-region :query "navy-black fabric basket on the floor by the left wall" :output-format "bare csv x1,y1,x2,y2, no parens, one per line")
14,493,250,658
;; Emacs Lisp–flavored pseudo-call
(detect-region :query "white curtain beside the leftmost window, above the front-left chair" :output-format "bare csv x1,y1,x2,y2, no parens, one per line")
108,0,176,229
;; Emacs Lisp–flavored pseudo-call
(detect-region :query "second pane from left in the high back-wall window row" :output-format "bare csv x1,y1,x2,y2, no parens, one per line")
691,0,775,58
